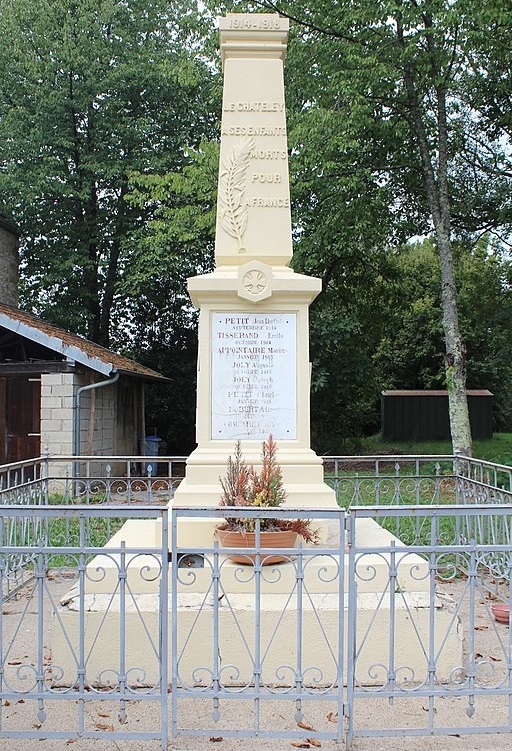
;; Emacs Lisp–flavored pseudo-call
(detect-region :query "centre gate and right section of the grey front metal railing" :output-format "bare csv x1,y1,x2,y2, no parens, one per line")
171,505,512,747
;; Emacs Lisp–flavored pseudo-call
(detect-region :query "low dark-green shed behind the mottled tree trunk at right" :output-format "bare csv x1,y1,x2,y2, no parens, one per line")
381,389,493,441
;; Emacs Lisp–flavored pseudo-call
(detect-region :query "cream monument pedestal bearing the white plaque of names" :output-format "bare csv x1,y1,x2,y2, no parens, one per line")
174,261,336,507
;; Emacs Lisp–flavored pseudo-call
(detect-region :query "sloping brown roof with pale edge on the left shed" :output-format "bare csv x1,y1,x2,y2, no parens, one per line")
0,303,169,381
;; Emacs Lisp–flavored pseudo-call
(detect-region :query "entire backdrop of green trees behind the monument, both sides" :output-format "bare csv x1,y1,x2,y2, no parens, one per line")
0,0,512,452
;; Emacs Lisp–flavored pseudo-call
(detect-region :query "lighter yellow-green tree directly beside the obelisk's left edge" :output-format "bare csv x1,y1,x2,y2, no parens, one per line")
121,143,219,454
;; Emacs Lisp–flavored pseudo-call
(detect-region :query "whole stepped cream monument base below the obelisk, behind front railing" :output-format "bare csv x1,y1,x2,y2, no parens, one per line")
52,519,462,687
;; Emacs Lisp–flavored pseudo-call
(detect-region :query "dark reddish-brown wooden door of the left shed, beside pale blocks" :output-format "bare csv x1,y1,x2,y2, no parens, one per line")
0,376,41,464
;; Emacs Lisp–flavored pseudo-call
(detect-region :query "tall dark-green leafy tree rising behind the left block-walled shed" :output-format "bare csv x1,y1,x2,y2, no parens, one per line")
0,0,215,346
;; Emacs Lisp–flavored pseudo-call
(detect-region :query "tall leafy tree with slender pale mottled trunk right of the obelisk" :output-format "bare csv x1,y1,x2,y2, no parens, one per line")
232,0,509,453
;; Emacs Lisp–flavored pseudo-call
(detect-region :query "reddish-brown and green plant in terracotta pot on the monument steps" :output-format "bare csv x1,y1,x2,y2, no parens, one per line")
219,435,318,544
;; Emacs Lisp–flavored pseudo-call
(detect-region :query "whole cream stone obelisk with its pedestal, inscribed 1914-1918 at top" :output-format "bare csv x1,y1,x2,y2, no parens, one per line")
175,14,335,507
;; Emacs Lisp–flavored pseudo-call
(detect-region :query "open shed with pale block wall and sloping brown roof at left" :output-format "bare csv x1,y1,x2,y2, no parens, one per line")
0,303,168,472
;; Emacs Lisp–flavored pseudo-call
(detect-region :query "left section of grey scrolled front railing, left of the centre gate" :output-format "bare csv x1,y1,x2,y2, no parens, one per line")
0,506,168,748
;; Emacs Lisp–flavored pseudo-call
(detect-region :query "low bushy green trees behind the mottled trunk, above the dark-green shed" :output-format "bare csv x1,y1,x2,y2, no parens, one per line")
374,237,512,430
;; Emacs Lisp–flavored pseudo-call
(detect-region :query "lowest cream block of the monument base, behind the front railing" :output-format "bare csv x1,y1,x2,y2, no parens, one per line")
52,592,462,688
